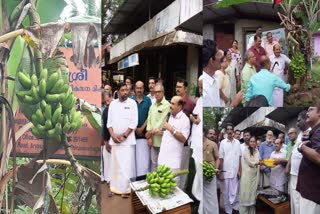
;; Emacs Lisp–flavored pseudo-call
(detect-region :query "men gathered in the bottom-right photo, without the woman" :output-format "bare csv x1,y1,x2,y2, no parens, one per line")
203,107,320,213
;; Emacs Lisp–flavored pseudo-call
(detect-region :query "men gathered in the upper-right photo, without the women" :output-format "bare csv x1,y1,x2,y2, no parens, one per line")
202,27,298,107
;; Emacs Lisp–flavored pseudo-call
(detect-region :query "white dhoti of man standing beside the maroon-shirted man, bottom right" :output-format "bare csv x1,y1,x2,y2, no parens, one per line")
289,175,301,214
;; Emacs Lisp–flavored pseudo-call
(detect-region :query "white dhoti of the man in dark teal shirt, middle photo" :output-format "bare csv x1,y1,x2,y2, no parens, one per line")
136,139,150,176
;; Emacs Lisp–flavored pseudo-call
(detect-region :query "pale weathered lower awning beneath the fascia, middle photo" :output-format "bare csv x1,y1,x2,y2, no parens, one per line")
109,30,202,64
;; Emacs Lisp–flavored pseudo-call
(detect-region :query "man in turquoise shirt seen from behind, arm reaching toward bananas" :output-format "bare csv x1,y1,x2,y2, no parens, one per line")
245,56,296,106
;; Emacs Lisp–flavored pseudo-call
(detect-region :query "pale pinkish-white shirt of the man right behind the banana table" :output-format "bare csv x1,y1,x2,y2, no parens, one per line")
158,111,190,169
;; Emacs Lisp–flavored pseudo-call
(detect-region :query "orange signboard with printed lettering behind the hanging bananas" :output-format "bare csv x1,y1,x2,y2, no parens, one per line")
15,48,101,159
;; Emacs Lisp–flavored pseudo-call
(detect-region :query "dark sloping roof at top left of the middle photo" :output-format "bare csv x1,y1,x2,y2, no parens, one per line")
103,0,174,34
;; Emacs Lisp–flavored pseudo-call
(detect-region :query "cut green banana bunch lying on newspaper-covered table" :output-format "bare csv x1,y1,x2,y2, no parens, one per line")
146,165,189,198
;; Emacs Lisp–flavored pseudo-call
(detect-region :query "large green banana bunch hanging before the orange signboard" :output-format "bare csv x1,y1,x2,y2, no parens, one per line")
16,65,83,142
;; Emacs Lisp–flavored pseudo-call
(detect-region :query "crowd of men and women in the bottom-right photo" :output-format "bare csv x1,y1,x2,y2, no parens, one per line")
202,107,320,214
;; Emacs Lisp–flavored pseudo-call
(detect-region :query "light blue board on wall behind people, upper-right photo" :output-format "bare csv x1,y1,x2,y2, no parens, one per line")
246,28,288,55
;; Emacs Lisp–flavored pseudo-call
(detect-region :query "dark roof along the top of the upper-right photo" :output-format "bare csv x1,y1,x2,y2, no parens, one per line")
203,1,282,24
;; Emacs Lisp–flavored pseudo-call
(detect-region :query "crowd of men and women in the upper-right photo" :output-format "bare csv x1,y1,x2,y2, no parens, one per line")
202,27,299,107
